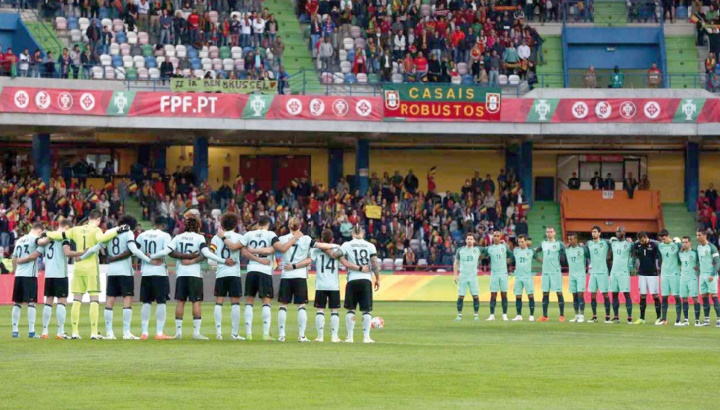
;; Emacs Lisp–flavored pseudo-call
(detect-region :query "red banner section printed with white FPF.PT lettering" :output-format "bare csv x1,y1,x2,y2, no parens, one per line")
127,92,248,119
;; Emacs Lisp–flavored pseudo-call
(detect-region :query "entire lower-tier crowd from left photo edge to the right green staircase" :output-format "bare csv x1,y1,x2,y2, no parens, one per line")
0,151,528,266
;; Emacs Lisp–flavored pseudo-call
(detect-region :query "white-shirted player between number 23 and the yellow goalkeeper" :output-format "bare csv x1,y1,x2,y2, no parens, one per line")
40,219,102,339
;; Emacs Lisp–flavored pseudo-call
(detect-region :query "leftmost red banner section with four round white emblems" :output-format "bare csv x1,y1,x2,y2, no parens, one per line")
0,87,113,115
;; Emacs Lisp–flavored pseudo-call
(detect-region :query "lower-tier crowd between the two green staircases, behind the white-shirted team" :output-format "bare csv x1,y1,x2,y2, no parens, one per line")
136,165,527,266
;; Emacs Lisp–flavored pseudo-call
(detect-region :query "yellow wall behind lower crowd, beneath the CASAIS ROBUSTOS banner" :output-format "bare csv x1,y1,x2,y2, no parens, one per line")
343,149,505,192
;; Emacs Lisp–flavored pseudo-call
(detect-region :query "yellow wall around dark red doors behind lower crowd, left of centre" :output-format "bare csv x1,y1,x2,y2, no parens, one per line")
167,145,330,188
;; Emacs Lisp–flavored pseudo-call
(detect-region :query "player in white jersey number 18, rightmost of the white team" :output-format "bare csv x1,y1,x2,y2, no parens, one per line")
340,225,380,343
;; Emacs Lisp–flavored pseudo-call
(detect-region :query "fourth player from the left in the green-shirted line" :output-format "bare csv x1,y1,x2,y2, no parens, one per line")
535,226,565,322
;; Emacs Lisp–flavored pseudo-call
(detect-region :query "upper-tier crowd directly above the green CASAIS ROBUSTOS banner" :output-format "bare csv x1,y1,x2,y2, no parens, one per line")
297,0,551,85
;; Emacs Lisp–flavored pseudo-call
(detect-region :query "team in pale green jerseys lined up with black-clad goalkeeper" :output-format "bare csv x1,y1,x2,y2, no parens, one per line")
453,226,720,327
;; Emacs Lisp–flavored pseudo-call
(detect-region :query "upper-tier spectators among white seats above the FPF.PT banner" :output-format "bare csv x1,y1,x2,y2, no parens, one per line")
0,0,292,80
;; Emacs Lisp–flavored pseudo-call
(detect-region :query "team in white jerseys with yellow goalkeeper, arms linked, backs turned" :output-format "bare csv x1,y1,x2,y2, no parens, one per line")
12,211,380,343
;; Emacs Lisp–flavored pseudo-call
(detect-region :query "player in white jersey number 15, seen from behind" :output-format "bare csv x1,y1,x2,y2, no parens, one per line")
157,213,236,340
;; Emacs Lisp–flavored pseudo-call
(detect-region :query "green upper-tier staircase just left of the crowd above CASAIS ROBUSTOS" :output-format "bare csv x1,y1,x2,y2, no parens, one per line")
263,0,324,94
